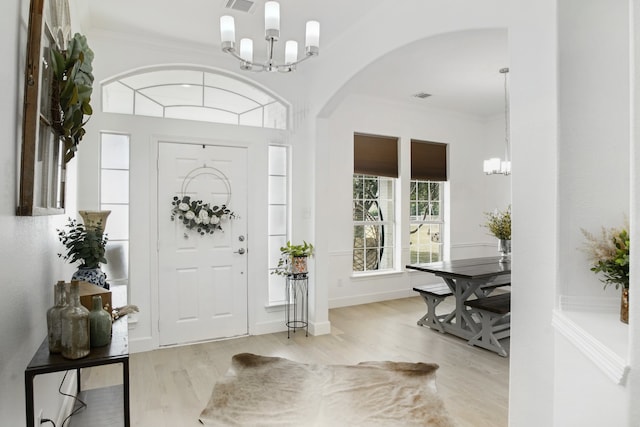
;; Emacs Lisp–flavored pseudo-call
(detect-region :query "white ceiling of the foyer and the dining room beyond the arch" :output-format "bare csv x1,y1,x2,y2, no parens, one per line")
81,0,508,117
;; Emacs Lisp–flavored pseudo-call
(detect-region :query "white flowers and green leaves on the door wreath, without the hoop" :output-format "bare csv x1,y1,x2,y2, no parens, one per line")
171,196,236,236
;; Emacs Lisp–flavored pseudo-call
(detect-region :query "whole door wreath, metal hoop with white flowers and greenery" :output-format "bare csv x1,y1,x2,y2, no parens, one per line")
171,165,237,236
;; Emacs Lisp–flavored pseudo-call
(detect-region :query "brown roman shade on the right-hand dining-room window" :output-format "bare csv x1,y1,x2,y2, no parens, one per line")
411,139,447,181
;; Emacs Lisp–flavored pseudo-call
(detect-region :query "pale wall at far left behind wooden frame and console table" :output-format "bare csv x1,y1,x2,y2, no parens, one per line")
0,0,75,426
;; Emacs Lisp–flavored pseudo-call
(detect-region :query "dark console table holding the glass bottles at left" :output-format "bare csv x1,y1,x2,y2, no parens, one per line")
24,319,130,427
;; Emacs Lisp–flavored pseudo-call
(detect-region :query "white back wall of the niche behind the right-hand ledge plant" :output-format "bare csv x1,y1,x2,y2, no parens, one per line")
558,0,630,296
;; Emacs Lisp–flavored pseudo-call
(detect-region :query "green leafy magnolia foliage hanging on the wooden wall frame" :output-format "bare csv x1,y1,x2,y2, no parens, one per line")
51,33,93,163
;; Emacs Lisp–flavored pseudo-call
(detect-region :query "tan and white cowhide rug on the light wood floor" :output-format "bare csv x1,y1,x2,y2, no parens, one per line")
200,353,455,427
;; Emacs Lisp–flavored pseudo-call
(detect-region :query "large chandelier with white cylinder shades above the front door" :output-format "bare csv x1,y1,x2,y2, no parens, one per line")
220,1,320,73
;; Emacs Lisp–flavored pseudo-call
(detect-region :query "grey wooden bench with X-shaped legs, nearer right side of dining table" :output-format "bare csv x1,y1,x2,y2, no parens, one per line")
464,292,511,357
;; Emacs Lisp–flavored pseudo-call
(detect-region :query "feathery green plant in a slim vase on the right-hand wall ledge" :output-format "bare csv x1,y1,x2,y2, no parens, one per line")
580,225,630,323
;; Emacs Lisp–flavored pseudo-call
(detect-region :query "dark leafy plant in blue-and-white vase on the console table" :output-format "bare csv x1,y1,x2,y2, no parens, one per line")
57,218,109,289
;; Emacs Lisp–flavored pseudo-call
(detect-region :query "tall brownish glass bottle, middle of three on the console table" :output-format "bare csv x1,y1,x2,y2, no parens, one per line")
61,280,91,359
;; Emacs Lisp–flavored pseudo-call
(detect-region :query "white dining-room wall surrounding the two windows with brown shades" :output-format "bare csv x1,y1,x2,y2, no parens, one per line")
316,95,510,307
